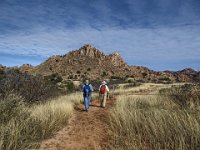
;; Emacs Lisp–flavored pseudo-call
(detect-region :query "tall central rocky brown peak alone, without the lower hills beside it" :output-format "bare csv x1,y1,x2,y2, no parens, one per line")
29,44,131,79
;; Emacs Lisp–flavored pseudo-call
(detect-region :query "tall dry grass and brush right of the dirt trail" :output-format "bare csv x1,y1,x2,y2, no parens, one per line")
110,85,200,150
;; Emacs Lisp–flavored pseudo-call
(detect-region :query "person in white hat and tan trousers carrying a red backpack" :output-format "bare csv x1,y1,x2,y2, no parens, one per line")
99,81,109,108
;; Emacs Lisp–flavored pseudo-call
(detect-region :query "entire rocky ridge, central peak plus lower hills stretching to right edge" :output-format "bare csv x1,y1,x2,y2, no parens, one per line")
0,44,200,83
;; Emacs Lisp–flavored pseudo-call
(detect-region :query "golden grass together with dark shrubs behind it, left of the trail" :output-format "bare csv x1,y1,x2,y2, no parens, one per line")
0,69,85,150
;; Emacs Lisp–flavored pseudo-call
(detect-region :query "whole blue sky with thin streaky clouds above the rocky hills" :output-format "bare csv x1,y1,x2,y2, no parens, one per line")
0,0,200,71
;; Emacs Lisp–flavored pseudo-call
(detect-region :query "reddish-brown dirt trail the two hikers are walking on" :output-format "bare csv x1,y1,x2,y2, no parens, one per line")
40,100,113,150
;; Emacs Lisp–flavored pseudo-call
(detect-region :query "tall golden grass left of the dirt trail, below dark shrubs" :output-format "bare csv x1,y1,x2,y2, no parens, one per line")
0,93,82,150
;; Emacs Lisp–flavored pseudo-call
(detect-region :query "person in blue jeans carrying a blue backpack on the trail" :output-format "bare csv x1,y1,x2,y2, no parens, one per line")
82,80,93,112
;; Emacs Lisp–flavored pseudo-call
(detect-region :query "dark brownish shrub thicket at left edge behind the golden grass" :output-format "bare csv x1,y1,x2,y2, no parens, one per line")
0,70,58,102
